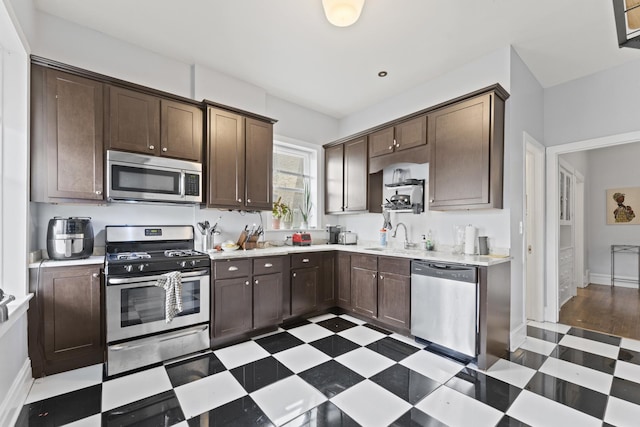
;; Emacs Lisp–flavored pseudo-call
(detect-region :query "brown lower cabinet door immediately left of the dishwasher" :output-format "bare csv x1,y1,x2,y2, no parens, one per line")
378,272,411,329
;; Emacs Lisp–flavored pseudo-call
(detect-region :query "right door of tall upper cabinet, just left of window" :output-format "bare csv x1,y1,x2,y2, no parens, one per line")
244,118,273,210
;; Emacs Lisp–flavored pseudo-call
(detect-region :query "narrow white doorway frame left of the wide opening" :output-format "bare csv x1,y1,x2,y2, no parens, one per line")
522,132,545,321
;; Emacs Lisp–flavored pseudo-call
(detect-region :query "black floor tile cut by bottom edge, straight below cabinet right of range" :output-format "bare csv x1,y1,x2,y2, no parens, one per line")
187,396,273,427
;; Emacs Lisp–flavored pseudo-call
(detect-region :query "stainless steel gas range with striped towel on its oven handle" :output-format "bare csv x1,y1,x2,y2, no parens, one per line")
105,225,211,376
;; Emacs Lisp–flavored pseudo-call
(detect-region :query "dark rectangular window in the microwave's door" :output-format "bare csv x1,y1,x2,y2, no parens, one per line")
111,164,181,195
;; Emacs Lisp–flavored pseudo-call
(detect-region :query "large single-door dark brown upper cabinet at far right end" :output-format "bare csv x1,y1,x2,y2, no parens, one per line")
429,91,505,210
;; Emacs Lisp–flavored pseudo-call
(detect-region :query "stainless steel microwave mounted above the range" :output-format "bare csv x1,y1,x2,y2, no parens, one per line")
106,150,202,203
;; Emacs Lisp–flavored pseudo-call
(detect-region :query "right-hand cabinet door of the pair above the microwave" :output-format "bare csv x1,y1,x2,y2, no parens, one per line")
160,99,203,162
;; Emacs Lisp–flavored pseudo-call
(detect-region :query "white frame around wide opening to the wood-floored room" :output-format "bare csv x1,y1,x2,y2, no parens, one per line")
544,131,640,323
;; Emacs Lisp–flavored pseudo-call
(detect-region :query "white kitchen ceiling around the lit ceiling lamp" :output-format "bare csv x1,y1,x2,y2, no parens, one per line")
36,0,640,118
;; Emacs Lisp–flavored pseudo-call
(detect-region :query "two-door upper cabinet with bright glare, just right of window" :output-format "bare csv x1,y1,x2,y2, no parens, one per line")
325,136,368,214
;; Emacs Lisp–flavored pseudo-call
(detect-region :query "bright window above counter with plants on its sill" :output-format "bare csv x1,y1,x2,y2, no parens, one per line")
273,141,318,228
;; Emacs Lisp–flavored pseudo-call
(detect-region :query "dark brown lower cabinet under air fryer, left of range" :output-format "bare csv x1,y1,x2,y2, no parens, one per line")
28,265,104,378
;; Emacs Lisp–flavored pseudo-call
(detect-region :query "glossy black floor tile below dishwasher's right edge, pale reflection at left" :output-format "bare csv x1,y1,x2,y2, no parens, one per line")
445,368,522,412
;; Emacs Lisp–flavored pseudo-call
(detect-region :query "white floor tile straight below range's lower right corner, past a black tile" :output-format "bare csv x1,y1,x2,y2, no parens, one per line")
175,371,247,418
